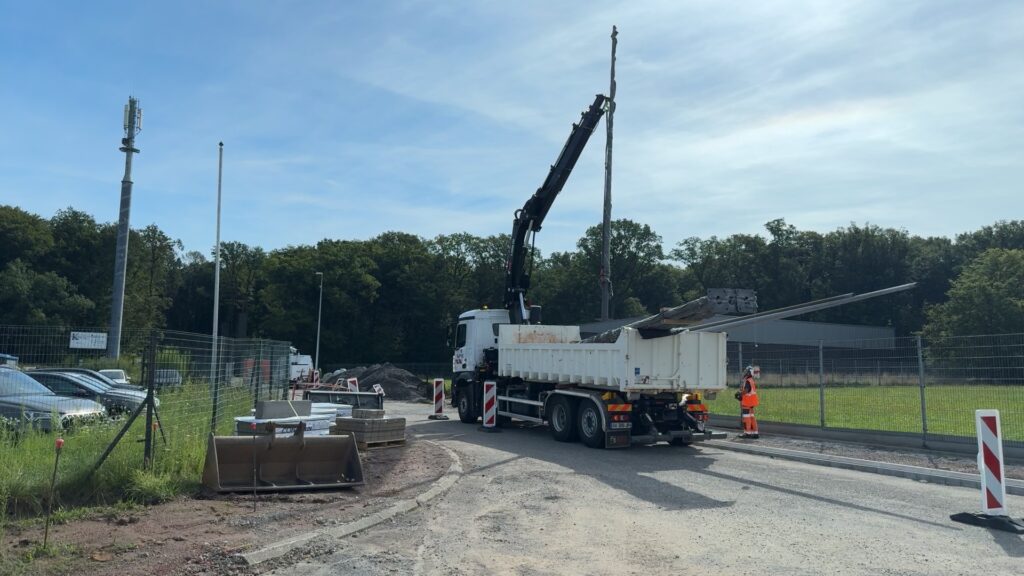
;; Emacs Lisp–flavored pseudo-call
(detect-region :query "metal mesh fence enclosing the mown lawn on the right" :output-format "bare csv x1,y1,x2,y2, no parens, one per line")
709,334,1024,446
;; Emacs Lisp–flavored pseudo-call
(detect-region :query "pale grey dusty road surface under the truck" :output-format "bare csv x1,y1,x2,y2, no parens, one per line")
278,404,1024,576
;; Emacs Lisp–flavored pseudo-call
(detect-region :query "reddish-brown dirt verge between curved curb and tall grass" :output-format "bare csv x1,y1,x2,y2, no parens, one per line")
0,441,450,576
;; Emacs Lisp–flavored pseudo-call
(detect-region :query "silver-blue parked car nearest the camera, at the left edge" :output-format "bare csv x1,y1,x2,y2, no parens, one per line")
0,366,106,431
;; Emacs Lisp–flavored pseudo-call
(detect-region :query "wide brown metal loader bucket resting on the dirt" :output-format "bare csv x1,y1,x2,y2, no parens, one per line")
203,425,364,492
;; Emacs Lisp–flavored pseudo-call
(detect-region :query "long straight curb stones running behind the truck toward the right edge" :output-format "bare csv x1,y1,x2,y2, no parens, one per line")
708,434,1024,496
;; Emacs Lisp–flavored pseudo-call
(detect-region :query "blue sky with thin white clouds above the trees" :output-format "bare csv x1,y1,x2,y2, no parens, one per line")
0,0,1024,253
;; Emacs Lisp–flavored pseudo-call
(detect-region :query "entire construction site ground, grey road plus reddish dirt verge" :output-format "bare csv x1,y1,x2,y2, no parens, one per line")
5,402,1024,576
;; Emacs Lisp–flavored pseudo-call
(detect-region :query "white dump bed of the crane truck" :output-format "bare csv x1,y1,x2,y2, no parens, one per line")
498,324,726,393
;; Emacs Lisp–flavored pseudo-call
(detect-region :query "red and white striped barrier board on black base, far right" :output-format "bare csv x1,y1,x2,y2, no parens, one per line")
949,410,1024,534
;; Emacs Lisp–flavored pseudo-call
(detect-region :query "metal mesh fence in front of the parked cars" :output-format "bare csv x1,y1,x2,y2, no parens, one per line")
0,326,289,513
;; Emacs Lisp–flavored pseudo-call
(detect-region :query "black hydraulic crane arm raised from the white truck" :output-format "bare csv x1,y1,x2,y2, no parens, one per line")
505,94,608,324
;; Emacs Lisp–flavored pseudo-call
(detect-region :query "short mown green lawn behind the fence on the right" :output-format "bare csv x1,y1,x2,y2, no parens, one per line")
708,385,1024,441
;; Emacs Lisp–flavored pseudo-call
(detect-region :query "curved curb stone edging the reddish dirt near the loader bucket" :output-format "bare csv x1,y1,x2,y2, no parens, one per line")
234,440,463,566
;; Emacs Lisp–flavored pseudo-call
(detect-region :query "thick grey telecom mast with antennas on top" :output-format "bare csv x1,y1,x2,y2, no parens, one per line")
106,96,142,358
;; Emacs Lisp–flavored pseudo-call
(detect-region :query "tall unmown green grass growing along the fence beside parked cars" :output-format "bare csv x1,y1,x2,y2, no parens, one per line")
0,377,265,516
